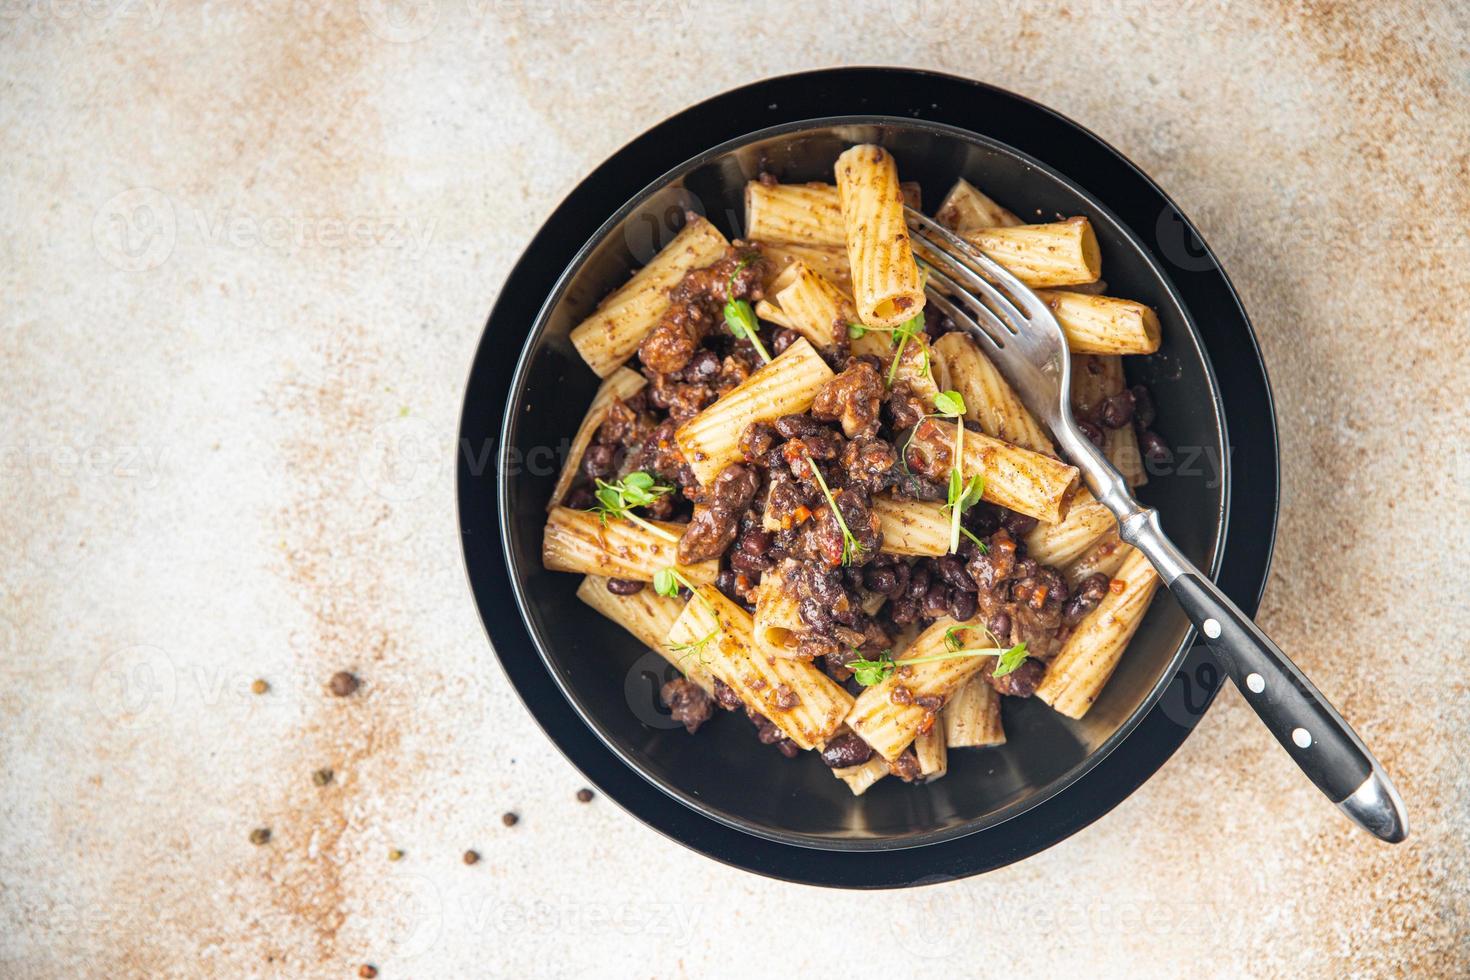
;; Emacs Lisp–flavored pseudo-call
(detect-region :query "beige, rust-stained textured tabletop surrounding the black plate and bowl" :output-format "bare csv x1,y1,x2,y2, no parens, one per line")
0,0,1470,977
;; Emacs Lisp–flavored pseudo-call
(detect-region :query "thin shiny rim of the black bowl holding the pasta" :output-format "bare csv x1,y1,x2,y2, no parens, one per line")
497,115,1232,851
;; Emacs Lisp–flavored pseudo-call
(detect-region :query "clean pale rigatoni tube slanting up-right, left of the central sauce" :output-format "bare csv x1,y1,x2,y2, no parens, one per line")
673,338,832,486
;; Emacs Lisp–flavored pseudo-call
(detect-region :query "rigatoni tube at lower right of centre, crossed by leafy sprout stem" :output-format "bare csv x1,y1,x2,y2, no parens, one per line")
847,619,1001,761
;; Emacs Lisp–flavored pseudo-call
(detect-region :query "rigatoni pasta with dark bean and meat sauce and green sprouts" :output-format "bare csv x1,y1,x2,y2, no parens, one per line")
542,145,1169,793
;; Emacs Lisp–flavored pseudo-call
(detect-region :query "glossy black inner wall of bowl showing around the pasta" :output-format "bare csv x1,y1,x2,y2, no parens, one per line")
500,119,1229,849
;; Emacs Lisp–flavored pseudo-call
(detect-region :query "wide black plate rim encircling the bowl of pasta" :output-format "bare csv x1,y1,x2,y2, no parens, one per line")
454,66,1280,889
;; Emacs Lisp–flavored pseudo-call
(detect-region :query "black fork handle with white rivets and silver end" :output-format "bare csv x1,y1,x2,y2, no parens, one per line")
1120,508,1408,843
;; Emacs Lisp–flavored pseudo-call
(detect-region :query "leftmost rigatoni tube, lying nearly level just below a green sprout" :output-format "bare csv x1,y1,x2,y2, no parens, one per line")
541,507,720,585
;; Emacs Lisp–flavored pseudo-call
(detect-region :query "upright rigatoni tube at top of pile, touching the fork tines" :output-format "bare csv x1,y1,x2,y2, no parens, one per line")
836,144,923,326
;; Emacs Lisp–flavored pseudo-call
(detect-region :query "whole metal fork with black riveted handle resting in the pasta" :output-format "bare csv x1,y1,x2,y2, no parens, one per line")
904,209,1408,843
